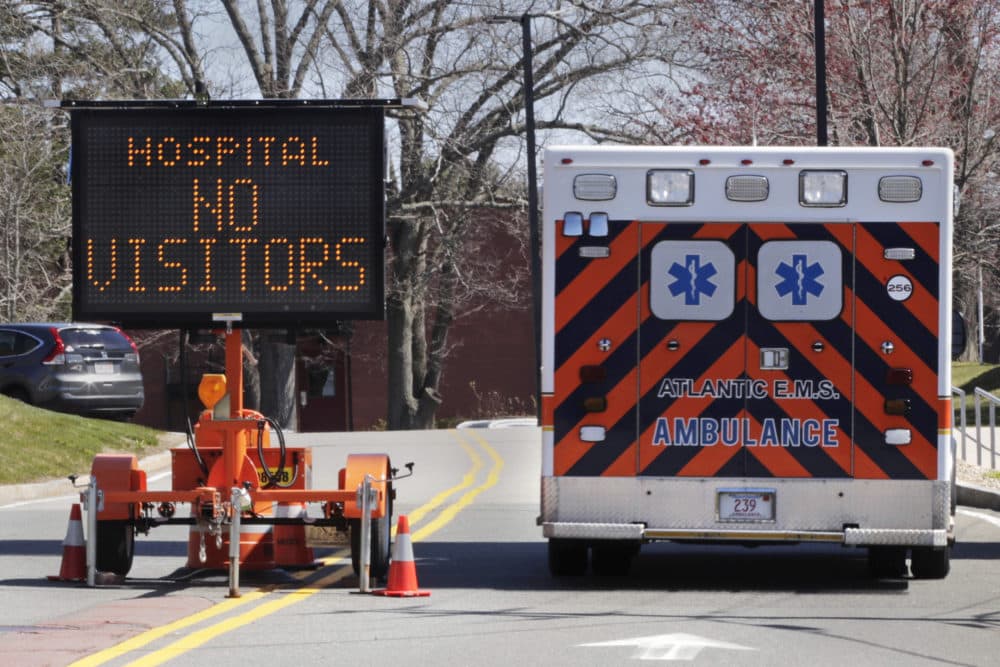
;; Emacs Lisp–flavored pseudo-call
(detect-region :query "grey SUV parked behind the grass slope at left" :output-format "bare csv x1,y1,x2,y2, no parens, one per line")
0,322,145,418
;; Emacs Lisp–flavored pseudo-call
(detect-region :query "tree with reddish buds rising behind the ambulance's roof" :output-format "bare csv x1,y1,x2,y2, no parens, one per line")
644,0,1000,360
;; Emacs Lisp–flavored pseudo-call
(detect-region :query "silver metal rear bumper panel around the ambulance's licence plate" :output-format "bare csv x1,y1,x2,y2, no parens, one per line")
539,477,952,547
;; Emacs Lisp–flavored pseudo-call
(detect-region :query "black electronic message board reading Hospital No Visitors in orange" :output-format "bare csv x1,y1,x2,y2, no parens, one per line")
71,105,385,328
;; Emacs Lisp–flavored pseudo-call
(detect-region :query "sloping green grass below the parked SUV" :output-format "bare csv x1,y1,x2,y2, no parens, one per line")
0,396,161,484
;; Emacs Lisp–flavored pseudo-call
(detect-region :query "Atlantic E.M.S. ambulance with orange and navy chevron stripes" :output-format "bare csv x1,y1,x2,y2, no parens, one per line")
539,146,956,579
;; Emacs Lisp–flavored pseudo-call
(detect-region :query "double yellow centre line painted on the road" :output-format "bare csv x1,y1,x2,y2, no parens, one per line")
71,429,504,667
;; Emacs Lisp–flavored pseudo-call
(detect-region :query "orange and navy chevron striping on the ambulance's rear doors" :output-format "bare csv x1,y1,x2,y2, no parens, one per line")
552,221,942,479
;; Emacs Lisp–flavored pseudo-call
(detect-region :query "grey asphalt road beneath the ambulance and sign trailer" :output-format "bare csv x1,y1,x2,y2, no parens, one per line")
0,428,1000,667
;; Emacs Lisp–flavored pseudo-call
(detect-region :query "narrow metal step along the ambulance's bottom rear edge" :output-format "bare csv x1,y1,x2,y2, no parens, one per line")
542,522,948,547
